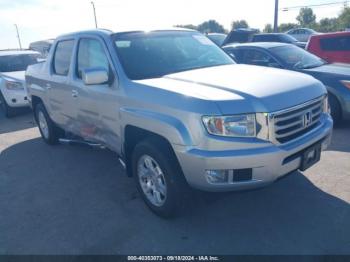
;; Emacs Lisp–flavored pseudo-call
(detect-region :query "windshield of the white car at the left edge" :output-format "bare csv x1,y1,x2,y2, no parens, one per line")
0,54,39,72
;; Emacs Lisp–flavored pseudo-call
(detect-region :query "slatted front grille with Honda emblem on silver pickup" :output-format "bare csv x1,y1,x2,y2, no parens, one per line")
270,97,324,143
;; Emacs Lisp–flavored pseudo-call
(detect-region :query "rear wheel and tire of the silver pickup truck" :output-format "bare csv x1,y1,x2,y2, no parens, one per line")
34,103,63,145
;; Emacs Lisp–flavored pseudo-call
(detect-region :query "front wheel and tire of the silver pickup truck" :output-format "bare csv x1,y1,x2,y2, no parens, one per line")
132,138,190,218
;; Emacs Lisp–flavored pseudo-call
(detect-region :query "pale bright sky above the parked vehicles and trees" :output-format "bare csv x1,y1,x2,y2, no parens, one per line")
0,0,342,49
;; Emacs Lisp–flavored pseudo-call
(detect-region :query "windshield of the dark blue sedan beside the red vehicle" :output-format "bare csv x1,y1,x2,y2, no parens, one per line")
270,45,325,69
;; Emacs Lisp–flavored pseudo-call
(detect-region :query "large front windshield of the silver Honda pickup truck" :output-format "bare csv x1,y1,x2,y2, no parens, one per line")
113,31,234,80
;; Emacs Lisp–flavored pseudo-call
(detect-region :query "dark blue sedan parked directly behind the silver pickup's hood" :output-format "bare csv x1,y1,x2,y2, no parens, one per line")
223,43,350,123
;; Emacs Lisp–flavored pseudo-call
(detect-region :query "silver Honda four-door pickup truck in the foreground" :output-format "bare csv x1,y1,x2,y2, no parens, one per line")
26,29,333,216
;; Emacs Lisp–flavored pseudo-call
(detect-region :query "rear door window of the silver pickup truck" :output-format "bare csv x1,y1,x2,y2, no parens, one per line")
52,40,74,76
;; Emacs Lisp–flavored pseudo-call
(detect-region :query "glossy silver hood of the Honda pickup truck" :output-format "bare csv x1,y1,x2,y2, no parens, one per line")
136,64,327,114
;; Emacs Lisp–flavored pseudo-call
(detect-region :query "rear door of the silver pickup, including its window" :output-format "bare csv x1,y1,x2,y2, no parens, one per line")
45,39,77,131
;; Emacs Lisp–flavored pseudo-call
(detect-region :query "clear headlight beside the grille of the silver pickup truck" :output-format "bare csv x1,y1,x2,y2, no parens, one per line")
203,114,256,137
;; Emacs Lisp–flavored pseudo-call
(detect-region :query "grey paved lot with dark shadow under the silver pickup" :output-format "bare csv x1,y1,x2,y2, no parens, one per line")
0,113,350,254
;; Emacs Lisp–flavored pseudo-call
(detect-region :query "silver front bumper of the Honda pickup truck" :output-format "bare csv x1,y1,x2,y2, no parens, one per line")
173,115,333,191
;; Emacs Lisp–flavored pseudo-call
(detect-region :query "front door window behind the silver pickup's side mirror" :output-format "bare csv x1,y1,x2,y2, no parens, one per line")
76,39,109,79
